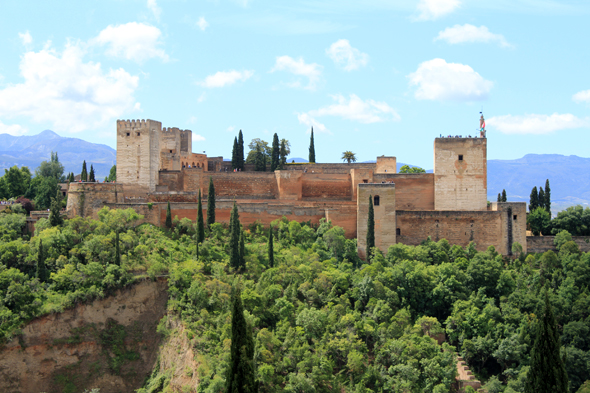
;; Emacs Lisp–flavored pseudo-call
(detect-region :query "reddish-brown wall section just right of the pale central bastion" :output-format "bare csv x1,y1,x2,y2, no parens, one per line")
301,171,352,200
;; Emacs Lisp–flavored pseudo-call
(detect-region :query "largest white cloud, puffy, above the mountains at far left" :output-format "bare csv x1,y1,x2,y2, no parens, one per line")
0,44,139,132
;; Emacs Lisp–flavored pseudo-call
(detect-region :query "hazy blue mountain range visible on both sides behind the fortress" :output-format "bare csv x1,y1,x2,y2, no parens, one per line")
0,130,590,210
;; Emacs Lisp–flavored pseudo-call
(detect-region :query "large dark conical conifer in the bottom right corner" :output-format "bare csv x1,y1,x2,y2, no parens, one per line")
524,287,568,393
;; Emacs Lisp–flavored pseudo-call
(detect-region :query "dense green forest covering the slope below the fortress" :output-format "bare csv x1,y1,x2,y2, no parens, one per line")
0,202,590,393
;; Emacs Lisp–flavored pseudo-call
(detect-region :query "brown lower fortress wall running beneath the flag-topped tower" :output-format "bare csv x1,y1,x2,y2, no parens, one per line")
396,210,506,252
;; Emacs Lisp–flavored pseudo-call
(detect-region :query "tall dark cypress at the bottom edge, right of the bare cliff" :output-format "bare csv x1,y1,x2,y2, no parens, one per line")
225,287,258,393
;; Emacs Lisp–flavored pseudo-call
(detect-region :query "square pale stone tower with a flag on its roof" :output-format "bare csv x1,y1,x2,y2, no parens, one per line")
434,138,488,211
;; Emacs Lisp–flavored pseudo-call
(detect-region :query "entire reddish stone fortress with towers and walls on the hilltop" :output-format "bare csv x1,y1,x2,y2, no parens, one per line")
67,120,526,258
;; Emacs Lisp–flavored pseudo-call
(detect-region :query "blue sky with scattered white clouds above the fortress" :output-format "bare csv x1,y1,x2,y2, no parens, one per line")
0,0,590,168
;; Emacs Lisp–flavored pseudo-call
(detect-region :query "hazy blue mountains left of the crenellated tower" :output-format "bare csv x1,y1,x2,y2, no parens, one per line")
0,130,117,180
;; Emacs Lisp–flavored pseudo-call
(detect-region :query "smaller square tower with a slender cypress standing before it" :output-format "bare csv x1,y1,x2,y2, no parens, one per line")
356,183,396,259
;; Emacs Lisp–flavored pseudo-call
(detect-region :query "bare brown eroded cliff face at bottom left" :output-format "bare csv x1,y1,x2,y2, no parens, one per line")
0,280,168,393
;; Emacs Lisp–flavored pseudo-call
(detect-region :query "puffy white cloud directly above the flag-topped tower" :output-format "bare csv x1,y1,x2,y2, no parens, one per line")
408,59,494,101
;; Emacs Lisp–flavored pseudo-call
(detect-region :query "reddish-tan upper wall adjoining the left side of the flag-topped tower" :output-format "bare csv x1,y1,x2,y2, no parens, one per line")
374,173,434,210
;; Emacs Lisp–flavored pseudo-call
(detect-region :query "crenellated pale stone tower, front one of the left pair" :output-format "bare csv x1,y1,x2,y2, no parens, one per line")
117,120,162,192
